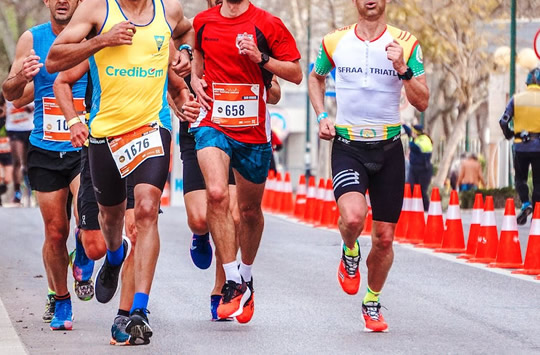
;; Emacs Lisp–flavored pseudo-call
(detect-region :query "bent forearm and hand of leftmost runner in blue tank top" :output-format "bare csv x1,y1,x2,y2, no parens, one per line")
2,31,39,101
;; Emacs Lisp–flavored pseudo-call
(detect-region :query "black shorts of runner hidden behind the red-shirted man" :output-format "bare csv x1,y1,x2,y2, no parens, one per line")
180,122,236,195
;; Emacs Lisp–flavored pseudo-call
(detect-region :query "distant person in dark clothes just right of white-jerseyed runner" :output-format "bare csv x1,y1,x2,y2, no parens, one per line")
403,125,433,211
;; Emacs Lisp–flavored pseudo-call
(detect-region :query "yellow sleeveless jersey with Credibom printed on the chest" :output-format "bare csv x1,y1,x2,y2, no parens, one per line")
89,0,172,138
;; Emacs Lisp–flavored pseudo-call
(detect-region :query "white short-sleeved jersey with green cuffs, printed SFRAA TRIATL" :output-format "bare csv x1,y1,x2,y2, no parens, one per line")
314,25,424,141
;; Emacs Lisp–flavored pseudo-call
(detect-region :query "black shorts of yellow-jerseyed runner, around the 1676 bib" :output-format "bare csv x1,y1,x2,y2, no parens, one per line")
89,127,171,206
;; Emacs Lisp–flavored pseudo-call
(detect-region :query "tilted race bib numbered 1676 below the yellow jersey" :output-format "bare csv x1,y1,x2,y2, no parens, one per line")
107,122,165,178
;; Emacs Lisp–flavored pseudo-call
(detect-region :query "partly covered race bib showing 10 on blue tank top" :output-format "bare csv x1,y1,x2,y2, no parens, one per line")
43,97,86,142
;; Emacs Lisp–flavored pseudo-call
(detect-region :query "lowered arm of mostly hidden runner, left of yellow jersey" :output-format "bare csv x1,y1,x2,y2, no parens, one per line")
53,60,89,148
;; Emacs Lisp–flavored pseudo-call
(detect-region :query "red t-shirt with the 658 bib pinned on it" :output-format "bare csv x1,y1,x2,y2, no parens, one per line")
191,4,300,144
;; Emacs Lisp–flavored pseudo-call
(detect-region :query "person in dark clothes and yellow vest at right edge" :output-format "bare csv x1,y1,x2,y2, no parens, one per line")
499,68,540,225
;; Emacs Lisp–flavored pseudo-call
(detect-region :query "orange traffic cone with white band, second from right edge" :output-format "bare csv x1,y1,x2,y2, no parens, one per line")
488,198,523,269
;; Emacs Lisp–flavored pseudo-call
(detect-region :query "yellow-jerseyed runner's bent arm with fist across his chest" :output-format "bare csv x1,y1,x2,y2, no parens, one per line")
45,0,136,73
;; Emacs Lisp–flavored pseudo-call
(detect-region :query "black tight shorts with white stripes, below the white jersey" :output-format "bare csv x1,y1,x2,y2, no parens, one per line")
332,136,405,223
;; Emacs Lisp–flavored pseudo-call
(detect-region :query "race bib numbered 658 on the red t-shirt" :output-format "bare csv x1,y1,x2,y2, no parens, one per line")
212,83,259,127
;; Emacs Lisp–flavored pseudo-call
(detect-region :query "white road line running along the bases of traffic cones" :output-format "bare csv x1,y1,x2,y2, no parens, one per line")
270,213,540,284
